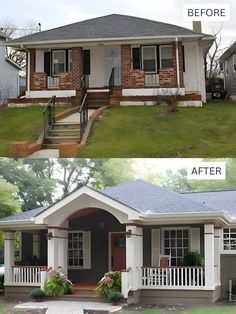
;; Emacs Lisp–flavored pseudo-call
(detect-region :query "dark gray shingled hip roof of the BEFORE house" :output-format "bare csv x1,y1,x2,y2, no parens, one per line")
9,14,205,43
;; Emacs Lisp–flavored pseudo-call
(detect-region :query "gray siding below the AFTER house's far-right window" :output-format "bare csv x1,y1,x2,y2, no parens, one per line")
221,254,236,299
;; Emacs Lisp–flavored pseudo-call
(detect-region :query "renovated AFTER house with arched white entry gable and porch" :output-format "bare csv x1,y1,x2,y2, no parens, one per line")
0,180,236,304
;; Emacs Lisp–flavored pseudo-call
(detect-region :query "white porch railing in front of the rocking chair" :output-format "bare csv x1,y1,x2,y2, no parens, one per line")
142,267,205,289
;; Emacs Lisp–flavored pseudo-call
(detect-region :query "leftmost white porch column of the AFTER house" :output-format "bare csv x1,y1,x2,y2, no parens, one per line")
4,232,15,285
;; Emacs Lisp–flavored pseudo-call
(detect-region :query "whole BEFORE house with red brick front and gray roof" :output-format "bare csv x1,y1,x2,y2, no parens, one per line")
7,14,214,106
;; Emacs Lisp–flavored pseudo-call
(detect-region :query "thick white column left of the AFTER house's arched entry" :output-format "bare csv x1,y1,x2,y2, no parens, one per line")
48,228,68,275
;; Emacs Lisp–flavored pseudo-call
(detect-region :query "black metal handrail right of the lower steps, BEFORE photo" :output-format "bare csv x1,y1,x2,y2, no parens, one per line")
79,75,89,141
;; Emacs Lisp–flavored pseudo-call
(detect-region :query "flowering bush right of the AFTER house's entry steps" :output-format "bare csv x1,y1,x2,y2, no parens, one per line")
95,271,121,298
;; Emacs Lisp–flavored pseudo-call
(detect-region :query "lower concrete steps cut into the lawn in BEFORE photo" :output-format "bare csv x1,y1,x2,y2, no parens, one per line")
43,122,80,149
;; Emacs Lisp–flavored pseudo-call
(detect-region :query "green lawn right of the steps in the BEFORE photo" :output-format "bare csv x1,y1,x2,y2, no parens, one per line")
80,102,236,158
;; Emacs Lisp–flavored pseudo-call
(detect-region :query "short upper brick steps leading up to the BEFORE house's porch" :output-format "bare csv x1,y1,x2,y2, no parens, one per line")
87,89,110,109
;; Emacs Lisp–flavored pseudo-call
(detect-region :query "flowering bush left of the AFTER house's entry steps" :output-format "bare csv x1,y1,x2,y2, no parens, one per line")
45,271,73,296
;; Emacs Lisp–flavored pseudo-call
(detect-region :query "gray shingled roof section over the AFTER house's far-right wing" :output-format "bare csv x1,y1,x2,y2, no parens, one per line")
182,191,236,217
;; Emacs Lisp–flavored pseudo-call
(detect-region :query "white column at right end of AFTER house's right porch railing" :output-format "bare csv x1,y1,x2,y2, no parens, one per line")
204,224,214,289
